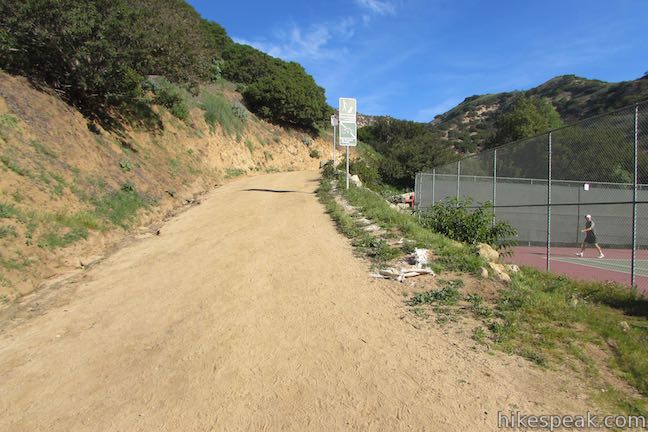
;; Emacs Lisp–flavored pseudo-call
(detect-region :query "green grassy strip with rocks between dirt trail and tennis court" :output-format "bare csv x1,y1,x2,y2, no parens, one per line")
317,169,648,415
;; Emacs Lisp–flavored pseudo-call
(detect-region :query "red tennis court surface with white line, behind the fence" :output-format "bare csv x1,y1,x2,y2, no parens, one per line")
506,246,648,294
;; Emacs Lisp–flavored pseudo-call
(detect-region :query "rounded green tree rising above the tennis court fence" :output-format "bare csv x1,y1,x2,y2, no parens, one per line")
487,96,563,147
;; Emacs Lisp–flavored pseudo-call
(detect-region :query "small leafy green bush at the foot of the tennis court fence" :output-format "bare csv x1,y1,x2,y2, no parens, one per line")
420,198,517,250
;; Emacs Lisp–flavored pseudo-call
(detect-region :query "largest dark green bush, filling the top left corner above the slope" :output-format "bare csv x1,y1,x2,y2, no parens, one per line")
0,0,232,115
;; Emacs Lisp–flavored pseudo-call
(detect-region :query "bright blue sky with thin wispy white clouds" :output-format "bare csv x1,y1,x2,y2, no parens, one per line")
189,0,648,121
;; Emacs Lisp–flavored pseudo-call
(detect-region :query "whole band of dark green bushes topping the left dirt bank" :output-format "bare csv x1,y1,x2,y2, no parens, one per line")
0,0,329,129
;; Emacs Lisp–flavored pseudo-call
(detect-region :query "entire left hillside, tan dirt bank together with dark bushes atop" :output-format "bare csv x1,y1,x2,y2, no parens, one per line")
0,0,342,307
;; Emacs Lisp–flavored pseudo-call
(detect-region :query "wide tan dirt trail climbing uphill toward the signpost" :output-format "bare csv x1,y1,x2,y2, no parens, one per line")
0,172,587,431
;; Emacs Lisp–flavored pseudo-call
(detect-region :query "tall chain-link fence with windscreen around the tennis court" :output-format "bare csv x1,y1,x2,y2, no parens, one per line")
415,101,648,292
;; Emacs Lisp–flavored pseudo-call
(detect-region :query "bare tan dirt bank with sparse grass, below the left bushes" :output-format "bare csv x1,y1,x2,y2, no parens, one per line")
0,73,329,307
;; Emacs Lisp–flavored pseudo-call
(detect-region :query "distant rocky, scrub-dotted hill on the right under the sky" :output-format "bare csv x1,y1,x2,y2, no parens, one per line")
431,75,648,149
